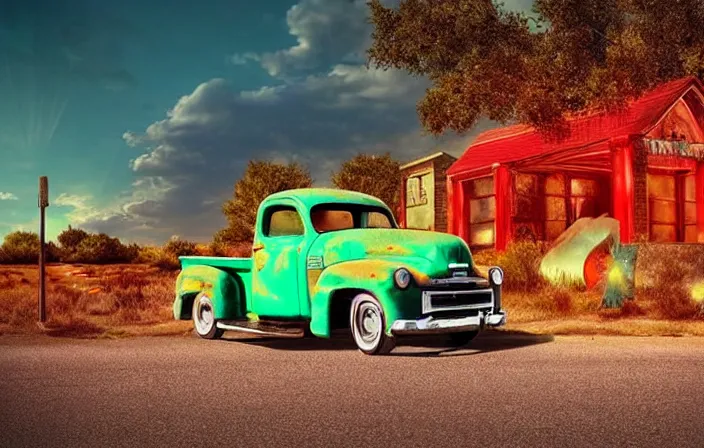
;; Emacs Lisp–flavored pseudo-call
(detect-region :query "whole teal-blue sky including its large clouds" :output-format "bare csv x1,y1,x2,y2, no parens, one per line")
0,0,531,244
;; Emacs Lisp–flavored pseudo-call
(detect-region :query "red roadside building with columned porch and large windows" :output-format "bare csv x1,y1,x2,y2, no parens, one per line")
447,78,704,250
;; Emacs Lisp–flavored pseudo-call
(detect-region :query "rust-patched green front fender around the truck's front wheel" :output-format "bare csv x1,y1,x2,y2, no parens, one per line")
310,259,421,338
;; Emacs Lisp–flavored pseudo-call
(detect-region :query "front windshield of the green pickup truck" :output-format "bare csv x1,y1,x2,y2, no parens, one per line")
310,204,396,233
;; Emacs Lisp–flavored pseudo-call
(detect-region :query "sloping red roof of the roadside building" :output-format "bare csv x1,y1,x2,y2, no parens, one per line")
447,77,702,175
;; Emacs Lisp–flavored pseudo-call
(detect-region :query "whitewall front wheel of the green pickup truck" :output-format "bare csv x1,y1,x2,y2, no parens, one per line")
350,293,395,355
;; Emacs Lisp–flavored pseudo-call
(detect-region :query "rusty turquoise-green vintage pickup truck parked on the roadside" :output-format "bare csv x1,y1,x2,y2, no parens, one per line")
173,188,506,355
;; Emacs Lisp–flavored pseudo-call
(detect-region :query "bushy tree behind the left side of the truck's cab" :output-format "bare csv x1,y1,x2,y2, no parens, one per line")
213,161,313,246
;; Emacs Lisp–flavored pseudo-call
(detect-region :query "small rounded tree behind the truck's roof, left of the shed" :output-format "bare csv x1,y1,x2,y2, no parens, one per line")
331,153,401,214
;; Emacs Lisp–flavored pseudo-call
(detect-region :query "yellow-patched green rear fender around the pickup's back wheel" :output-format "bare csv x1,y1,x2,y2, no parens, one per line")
173,265,244,320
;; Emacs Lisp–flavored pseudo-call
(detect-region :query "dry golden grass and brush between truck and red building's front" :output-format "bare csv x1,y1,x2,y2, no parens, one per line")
484,243,704,335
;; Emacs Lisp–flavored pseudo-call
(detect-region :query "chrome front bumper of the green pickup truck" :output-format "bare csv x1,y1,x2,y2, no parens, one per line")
391,310,506,336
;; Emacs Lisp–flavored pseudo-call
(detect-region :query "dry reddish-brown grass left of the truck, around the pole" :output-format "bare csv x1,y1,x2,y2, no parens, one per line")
0,265,181,336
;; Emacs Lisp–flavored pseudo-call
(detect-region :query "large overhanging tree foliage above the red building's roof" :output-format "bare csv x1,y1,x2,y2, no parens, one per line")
368,0,704,134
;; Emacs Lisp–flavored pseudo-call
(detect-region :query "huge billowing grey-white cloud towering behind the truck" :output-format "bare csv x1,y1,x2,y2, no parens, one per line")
74,0,490,242
